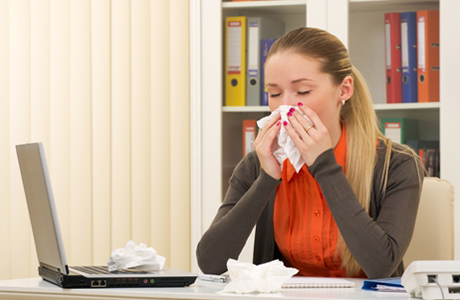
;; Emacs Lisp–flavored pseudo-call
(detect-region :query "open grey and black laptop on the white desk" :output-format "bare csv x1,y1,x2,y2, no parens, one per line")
16,143,198,288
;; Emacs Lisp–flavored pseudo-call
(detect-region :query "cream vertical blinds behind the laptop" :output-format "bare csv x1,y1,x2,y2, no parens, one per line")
0,0,190,279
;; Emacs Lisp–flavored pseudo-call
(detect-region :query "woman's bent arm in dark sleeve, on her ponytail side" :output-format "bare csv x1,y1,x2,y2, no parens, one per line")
310,149,422,278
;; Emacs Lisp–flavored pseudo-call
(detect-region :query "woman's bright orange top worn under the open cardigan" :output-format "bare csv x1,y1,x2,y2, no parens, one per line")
273,126,347,277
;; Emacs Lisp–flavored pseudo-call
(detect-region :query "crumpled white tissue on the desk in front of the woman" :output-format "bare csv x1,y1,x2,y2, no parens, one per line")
222,259,299,294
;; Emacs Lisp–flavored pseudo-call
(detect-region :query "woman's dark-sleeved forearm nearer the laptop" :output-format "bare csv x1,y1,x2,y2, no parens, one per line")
196,152,280,274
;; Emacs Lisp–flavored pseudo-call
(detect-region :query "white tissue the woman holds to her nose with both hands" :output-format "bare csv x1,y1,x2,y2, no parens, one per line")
257,105,313,173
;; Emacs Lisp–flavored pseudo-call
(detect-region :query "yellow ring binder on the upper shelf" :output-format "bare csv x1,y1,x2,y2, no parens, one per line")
225,16,247,106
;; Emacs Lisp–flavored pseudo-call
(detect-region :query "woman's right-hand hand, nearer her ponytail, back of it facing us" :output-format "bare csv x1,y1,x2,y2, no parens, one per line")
283,106,332,167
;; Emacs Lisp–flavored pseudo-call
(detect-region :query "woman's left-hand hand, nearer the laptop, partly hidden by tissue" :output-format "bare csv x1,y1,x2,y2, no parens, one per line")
254,114,281,179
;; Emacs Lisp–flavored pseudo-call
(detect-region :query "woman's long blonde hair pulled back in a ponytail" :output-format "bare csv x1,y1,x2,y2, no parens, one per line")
267,28,422,276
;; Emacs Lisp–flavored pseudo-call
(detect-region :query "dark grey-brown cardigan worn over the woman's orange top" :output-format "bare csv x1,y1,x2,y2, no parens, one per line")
196,142,423,278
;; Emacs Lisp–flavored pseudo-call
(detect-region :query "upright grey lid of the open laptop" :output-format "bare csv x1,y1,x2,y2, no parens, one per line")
16,143,68,274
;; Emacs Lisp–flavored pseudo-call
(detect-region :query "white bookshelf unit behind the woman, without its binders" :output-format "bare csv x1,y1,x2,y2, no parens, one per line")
192,0,460,272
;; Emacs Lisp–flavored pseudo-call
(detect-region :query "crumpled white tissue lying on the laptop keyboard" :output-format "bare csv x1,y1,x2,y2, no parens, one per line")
107,240,166,272
